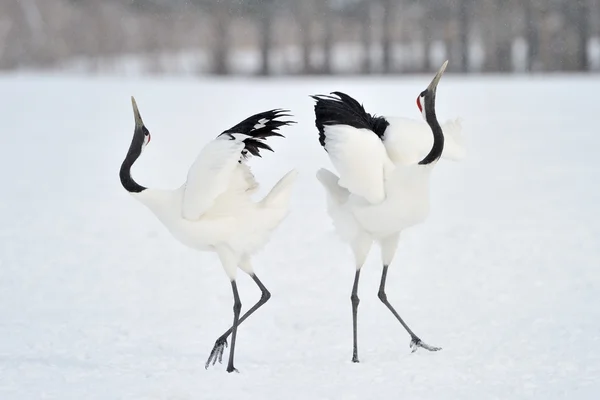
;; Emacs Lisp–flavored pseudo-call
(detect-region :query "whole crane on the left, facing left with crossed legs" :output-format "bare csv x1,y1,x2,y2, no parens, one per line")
120,98,297,372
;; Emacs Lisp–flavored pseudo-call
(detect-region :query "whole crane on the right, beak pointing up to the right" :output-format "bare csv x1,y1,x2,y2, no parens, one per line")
313,62,465,362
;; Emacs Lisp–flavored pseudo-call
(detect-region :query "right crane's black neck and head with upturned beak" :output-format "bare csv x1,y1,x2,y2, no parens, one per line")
417,61,448,165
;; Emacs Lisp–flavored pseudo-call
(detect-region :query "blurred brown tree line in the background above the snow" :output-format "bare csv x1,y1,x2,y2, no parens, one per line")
0,0,600,75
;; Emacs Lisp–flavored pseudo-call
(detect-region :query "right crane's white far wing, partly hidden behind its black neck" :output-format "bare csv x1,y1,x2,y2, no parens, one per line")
383,117,465,165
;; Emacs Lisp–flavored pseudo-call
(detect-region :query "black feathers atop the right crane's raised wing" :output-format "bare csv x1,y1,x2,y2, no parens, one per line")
310,92,390,147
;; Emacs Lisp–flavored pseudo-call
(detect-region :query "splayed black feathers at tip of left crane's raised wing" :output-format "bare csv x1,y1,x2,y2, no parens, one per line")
219,109,296,162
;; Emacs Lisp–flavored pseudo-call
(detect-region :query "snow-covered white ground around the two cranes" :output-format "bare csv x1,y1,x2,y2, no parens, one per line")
0,75,600,400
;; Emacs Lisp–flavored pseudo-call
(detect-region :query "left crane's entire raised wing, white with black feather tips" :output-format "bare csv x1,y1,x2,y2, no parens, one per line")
182,110,293,221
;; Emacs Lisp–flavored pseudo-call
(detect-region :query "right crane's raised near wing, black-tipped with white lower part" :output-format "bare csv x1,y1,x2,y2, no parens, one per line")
312,92,394,204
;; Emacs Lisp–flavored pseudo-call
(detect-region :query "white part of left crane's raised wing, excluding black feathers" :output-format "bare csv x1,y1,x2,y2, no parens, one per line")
182,134,247,221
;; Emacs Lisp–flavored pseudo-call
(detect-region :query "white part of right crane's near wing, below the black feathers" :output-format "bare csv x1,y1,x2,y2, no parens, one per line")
324,125,394,204
